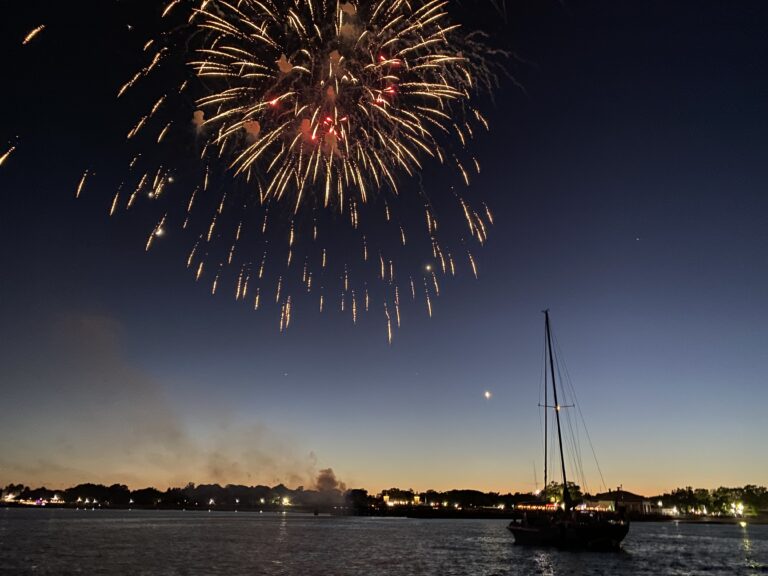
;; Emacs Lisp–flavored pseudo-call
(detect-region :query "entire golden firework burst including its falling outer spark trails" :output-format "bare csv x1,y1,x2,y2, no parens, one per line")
108,0,504,341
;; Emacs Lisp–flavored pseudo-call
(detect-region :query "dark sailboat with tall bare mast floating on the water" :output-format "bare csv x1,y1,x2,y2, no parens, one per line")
509,310,629,550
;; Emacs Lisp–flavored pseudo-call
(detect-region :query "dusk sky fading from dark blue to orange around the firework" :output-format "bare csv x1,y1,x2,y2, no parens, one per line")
0,0,768,494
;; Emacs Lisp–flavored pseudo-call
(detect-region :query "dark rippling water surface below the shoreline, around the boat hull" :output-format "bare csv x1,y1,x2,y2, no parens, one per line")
0,509,768,576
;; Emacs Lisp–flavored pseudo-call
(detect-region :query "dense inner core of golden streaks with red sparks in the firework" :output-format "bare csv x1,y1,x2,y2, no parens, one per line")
191,0,480,211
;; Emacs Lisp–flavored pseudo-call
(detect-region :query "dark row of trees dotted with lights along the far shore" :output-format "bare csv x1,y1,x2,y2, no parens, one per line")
1,482,768,515
